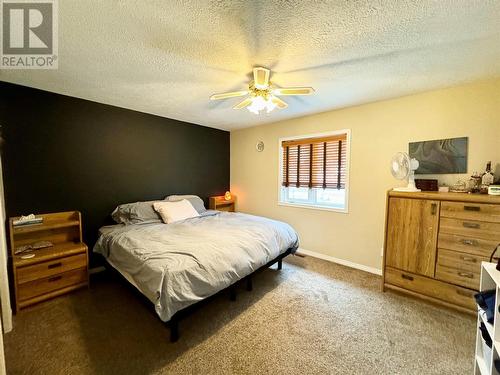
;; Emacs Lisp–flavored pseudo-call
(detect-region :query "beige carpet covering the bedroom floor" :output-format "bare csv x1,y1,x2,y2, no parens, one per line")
5,257,475,375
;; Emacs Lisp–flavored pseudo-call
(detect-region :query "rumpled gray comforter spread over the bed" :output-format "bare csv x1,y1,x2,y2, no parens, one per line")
94,213,298,321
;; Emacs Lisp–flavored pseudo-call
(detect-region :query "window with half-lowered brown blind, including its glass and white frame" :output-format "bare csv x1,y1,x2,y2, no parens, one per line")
280,130,350,212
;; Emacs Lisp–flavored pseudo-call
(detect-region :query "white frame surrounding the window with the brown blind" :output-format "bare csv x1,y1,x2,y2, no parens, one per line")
278,129,351,214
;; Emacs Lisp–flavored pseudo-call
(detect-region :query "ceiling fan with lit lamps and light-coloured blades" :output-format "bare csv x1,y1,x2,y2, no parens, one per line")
210,67,314,115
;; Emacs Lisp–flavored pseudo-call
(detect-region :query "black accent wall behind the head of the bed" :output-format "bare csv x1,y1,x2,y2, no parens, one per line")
0,82,229,264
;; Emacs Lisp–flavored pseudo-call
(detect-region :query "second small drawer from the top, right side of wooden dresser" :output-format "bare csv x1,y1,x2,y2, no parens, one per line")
439,217,500,241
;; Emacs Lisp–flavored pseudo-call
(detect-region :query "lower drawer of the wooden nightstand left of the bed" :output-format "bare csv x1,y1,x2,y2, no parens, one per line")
17,268,87,301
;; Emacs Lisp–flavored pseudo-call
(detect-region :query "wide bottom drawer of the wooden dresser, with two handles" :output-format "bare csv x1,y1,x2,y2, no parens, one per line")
385,267,476,310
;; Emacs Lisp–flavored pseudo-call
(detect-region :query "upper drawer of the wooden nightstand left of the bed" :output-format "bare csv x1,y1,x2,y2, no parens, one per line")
17,253,87,284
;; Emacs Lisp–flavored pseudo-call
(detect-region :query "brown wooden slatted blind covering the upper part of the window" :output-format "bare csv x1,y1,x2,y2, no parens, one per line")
281,134,347,189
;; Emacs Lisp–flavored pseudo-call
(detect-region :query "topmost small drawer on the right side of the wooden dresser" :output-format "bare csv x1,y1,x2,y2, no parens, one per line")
441,202,500,223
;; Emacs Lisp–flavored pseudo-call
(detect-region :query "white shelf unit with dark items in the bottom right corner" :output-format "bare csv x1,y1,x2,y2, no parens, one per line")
474,262,500,375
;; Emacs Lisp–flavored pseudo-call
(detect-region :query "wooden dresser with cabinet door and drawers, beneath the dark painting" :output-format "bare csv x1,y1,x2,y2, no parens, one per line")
382,191,500,313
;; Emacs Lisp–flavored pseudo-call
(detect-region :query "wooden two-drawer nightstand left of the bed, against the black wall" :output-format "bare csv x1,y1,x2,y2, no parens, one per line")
9,211,89,312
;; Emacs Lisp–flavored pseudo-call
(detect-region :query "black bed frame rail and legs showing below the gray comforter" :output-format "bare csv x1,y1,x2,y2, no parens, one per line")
165,249,292,342
